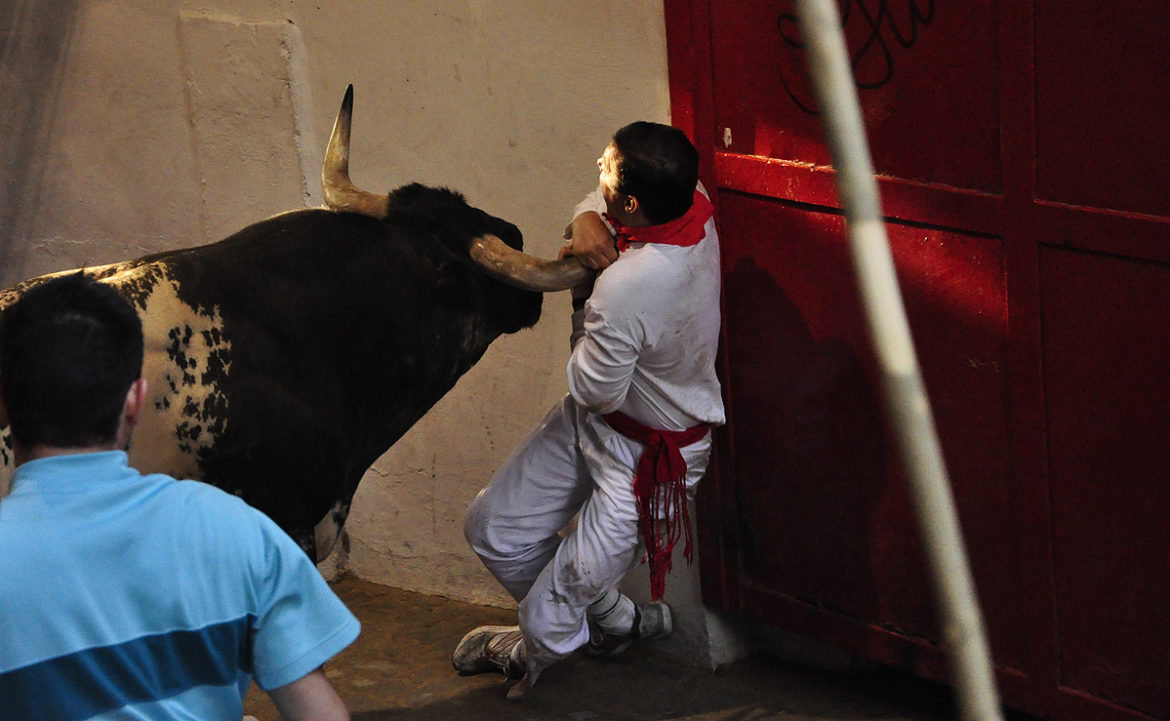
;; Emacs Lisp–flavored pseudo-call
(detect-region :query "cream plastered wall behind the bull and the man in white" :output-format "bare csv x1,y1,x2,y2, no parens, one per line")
0,0,668,605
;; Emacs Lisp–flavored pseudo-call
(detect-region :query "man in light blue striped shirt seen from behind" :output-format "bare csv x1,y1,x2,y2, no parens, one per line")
0,273,359,721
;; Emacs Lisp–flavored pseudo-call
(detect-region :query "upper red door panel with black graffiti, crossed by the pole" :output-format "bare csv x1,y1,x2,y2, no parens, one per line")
710,0,1000,192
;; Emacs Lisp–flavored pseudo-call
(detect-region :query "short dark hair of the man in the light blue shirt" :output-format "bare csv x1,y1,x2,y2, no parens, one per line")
0,273,143,448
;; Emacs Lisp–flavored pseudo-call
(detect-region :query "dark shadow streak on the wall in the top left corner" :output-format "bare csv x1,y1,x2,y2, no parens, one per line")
0,0,80,267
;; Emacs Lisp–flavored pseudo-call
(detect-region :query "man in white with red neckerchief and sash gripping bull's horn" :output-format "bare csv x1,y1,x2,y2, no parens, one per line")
453,123,724,698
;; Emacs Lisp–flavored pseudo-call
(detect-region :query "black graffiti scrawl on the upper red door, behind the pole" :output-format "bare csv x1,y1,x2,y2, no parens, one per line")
776,0,935,115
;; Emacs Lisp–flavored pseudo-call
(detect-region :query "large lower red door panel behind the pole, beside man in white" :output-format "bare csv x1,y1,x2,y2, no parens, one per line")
720,188,1026,667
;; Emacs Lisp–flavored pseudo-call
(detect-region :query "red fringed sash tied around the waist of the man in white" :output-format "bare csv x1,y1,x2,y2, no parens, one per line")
601,407,711,600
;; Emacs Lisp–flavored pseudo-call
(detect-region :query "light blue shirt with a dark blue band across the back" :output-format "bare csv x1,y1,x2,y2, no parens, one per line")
0,451,359,721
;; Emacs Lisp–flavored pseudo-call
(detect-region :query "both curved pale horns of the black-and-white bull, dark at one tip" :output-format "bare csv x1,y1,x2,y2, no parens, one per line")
321,85,592,293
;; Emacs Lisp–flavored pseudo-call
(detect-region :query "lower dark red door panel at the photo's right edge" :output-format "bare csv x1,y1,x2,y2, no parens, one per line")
1040,248,1170,719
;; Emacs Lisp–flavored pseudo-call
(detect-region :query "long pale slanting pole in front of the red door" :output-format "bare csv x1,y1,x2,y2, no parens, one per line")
797,5,1003,721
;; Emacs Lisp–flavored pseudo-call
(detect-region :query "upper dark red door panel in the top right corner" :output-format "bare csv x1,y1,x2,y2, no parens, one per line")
1035,5,1170,215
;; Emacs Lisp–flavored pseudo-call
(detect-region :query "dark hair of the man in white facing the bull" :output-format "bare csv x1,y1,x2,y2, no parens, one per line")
613,121,698,225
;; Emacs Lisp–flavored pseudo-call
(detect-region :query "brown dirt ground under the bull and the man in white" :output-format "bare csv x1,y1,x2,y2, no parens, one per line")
245,578,978,721
